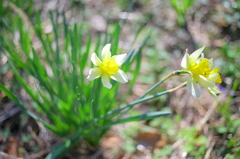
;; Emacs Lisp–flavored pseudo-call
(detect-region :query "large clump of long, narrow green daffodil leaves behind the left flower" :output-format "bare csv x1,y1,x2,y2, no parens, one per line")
0,3,172,158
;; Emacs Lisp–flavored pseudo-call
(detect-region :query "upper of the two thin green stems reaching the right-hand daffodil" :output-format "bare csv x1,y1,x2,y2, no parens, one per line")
138,70,188,99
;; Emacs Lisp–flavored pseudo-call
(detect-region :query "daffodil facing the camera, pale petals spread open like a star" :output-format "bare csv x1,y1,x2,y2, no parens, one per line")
87,44,128,89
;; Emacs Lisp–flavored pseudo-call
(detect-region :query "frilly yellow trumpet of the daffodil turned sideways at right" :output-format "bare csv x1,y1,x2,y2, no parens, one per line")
188,59,222,83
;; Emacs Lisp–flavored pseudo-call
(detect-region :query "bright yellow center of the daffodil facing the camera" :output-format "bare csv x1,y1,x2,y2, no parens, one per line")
99,58,119,75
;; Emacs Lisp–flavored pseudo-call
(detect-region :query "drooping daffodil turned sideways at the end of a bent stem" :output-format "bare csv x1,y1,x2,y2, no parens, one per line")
181,47,222,98
